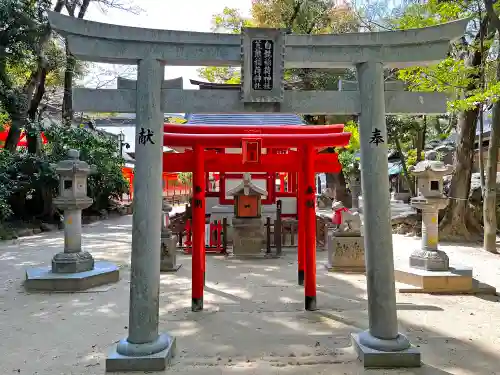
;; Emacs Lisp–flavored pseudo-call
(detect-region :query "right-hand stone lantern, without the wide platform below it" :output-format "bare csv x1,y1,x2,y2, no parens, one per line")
410,160,453,271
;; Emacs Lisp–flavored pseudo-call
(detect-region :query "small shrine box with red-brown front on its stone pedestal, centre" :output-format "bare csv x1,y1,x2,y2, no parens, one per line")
227,173,267,256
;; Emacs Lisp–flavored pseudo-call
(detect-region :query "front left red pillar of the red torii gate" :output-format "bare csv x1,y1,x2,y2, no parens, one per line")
191,145,205,311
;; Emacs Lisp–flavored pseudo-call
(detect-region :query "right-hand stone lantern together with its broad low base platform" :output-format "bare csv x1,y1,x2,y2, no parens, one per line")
395,160,473,293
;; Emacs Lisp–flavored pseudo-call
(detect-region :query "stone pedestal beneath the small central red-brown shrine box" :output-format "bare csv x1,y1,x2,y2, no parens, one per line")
233,217,265,256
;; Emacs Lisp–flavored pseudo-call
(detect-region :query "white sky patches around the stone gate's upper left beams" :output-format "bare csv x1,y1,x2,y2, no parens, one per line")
83,0,251,151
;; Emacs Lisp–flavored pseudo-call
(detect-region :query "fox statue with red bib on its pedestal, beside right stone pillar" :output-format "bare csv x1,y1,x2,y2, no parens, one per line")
326,201,365,273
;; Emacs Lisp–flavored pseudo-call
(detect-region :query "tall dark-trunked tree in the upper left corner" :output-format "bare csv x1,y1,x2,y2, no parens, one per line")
0,0,64,152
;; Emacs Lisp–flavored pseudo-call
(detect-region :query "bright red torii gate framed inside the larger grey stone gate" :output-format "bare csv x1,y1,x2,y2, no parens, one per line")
163,124,351,311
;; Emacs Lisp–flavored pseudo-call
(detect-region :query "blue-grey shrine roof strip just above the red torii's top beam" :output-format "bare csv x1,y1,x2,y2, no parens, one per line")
186,113,305,125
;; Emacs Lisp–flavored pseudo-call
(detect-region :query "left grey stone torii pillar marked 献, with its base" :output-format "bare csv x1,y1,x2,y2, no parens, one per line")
106,59,175,371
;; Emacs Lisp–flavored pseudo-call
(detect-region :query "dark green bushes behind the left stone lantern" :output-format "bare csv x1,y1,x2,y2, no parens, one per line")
0,126,128,221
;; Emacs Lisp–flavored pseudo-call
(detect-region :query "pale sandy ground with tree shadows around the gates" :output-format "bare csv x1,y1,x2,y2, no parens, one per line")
0,216,500,375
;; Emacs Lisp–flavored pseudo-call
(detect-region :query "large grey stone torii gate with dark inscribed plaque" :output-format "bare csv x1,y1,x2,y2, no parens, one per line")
49,13,467,371
